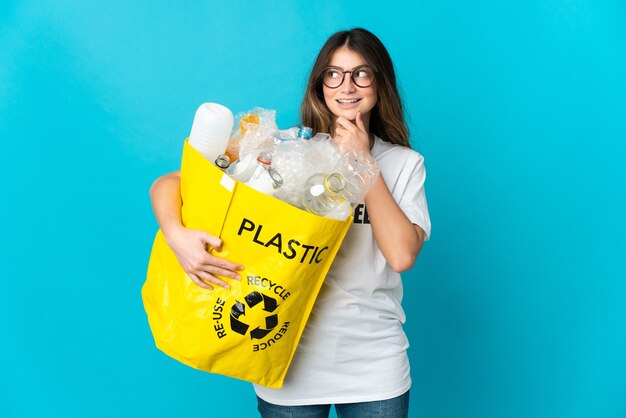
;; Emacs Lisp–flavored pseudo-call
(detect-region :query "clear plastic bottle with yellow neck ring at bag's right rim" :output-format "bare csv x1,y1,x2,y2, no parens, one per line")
302,173,346,216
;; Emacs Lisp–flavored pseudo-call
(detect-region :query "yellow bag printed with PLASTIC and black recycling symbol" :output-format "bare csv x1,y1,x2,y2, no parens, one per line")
142,142,352,388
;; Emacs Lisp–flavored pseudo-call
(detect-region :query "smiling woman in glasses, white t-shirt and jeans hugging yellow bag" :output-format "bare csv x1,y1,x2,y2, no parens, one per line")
151,28,430,417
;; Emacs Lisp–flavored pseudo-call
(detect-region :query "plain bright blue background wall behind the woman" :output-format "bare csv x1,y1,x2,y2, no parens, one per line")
0,0,626,418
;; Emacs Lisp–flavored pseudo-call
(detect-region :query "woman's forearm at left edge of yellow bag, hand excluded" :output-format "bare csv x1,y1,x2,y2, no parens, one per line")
150,172,182,239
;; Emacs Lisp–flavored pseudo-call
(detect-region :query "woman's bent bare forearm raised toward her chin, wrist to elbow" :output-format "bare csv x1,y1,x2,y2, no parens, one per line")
365,175,424,272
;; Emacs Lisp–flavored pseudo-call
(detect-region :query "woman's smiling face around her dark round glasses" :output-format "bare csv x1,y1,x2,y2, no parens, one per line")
323,46,377,129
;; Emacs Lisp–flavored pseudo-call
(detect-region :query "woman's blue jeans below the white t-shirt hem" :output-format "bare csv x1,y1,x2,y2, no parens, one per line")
257,391,409,418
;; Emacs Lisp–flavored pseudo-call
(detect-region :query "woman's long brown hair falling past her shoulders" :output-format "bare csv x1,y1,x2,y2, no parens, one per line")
300,28,411,148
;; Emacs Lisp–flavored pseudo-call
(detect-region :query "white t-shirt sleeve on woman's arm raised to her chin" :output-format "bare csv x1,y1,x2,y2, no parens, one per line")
398,154,430,241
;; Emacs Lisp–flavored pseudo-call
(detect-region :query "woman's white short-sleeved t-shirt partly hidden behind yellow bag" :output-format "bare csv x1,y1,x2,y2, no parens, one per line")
254,137,430,405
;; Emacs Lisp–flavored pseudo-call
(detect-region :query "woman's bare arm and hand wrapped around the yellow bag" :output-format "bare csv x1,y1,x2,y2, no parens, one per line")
150,171,243,289
